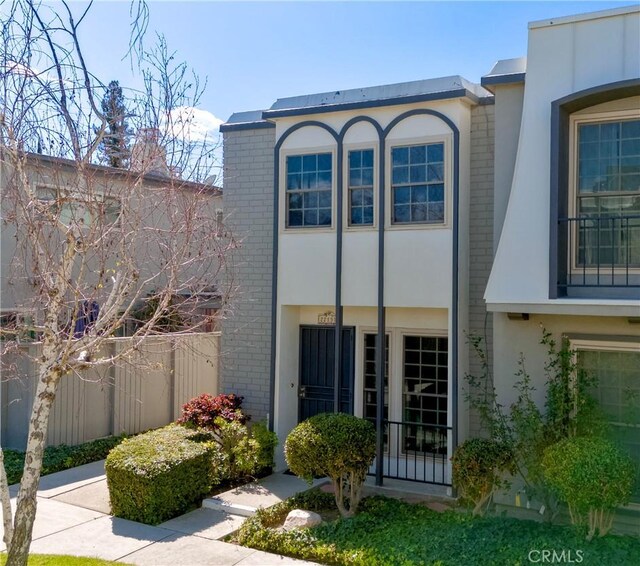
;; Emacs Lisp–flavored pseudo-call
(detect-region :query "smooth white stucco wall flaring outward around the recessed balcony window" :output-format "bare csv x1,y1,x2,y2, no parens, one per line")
485,7,640,305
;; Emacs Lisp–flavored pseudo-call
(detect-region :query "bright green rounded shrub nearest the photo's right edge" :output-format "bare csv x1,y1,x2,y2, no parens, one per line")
542,437,635,539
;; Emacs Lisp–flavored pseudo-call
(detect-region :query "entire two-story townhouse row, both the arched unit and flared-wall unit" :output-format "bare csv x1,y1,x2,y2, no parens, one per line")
221,7,640,500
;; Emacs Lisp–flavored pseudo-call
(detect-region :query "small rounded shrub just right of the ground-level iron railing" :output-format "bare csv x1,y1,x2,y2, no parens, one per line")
451,438,513,515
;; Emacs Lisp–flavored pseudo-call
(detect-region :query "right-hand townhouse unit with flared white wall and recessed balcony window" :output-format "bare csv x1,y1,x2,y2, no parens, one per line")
482,7,640,503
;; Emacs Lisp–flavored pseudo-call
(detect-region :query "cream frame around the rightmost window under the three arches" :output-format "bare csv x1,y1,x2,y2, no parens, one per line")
385,134,453,230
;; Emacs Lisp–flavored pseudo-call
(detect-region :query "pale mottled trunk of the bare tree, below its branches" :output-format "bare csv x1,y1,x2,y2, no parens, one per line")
7,370,60,566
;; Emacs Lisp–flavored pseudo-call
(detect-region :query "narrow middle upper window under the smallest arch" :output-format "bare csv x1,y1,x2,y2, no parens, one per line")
348,149,373,226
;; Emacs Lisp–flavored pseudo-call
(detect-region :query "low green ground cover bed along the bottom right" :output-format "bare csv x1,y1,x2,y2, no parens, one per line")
235,496,640,566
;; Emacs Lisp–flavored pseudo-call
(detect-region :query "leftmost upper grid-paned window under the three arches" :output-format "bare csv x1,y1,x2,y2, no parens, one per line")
286,153,332,228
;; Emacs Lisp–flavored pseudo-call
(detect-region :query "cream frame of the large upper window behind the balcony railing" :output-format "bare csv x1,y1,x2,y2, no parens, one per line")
567,110,640,275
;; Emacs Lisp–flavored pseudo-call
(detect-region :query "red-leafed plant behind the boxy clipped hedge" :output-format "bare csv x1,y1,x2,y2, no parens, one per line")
178,393,249,430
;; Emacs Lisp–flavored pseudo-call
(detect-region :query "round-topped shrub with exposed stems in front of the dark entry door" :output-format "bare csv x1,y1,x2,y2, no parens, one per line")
284,413,376,517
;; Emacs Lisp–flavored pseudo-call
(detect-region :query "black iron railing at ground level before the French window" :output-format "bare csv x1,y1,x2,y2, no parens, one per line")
372,420,453,486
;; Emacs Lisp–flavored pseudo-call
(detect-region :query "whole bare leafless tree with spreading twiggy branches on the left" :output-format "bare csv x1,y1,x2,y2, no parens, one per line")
0,0,235,565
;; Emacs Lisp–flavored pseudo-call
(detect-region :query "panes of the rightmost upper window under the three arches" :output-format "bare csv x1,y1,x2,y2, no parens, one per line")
391,142,445,224
